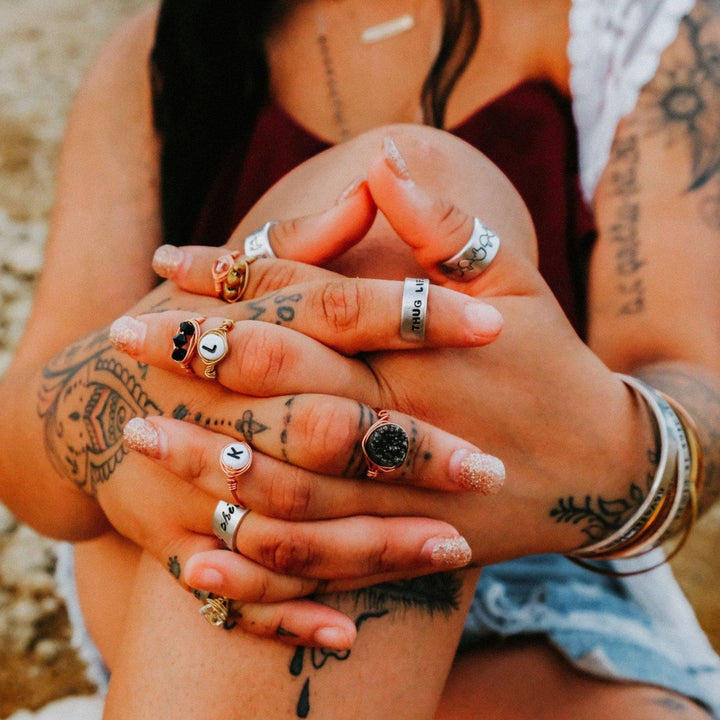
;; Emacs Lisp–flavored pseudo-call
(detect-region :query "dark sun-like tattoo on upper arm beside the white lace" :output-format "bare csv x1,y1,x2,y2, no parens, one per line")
637,0,720,230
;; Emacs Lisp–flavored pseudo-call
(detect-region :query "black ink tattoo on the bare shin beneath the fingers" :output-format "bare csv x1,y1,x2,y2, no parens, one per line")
289,573,462,718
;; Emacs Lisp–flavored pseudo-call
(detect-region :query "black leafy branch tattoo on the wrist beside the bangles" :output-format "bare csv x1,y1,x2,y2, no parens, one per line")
550,446,658,544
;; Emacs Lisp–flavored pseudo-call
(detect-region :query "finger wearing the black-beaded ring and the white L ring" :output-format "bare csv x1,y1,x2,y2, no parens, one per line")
110,311,379,405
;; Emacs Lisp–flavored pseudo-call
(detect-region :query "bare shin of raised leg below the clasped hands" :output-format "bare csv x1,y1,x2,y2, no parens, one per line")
94,557,477,720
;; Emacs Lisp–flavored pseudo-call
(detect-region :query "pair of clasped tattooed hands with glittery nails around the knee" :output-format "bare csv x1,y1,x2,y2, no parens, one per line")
99,135,635,649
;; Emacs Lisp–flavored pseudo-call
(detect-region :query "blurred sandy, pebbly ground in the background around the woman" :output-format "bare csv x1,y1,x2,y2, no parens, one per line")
0,0,720,718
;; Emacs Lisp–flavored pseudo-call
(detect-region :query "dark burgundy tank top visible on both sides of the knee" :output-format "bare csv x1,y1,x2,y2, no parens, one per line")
195,81,595,336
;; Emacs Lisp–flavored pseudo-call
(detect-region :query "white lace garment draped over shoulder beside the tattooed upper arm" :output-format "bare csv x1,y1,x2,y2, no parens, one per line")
568,0,695,202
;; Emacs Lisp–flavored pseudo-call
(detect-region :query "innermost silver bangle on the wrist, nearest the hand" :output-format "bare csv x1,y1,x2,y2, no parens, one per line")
568,373,684,558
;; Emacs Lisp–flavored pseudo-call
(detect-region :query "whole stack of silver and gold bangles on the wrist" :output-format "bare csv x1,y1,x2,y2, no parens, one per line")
568,375,703,576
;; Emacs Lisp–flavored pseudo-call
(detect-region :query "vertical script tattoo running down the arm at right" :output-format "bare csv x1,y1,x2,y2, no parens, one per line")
608,134,645,315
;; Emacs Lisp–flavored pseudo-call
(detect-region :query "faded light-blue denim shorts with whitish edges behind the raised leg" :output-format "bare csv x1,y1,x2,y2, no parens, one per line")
56,543,720,720
